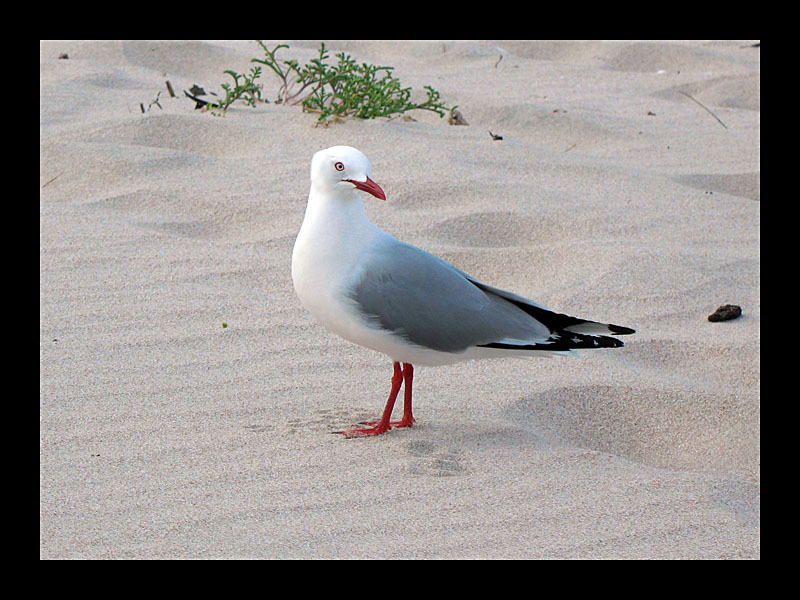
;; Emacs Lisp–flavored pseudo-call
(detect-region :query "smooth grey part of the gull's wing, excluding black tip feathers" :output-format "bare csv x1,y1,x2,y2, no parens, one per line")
349,240,552,352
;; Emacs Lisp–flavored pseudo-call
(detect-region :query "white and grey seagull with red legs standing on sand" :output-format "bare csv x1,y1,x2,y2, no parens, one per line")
292,146,635,438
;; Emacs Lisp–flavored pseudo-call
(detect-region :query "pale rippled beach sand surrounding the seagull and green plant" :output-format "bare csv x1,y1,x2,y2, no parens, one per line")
39,41,761,559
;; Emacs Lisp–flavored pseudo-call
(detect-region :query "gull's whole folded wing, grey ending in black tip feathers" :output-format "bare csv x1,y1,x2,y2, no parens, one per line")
348,236,634,353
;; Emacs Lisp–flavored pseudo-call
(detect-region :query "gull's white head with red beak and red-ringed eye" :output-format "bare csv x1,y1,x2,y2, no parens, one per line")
311,146,386,200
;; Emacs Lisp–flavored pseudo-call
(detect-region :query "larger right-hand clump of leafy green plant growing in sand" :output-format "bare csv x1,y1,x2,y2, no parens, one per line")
251,40,450,122
